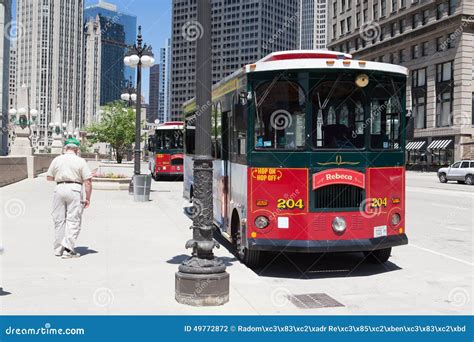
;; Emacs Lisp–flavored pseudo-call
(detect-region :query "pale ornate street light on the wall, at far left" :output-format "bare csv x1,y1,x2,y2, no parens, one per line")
8,84,38,156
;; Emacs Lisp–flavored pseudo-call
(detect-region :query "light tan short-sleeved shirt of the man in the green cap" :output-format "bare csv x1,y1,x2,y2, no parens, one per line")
46,152,92,183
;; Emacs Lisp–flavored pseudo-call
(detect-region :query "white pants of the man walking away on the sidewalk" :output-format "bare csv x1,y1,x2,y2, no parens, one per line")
52,184,84,254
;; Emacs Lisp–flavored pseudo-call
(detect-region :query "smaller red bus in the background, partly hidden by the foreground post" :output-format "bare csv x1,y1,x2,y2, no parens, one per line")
148,122,184,181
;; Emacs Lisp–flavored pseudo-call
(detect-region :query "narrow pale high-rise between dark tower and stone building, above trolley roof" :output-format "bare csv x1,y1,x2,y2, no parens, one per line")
298,0,328,50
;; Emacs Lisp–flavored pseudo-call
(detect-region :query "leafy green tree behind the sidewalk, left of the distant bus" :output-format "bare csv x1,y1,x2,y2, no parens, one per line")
86,101,135,164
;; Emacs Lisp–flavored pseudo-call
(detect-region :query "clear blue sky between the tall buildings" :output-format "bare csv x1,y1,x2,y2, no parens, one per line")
85,0,172,103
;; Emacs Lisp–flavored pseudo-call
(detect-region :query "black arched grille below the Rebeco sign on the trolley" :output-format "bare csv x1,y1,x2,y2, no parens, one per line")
314,184,364,209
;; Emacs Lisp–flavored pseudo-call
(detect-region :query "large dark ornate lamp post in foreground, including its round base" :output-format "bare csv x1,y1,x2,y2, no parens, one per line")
175,0,229,306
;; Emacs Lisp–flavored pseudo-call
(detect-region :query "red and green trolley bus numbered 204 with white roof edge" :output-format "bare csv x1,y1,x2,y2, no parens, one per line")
184,51,408,266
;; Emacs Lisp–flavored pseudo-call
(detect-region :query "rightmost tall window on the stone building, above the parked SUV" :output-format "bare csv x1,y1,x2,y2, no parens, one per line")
436,61,453,127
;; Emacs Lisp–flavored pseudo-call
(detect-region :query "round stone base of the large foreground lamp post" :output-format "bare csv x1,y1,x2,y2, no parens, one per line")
175,272,230,306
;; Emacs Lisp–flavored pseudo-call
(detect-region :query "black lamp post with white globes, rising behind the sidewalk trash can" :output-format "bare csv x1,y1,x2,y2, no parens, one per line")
124,26,155,176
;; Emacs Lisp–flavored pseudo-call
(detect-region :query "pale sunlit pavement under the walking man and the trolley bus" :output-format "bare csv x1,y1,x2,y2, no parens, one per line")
0,169,474,315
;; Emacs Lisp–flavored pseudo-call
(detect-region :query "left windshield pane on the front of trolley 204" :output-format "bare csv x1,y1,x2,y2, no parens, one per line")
255,81,306,150
